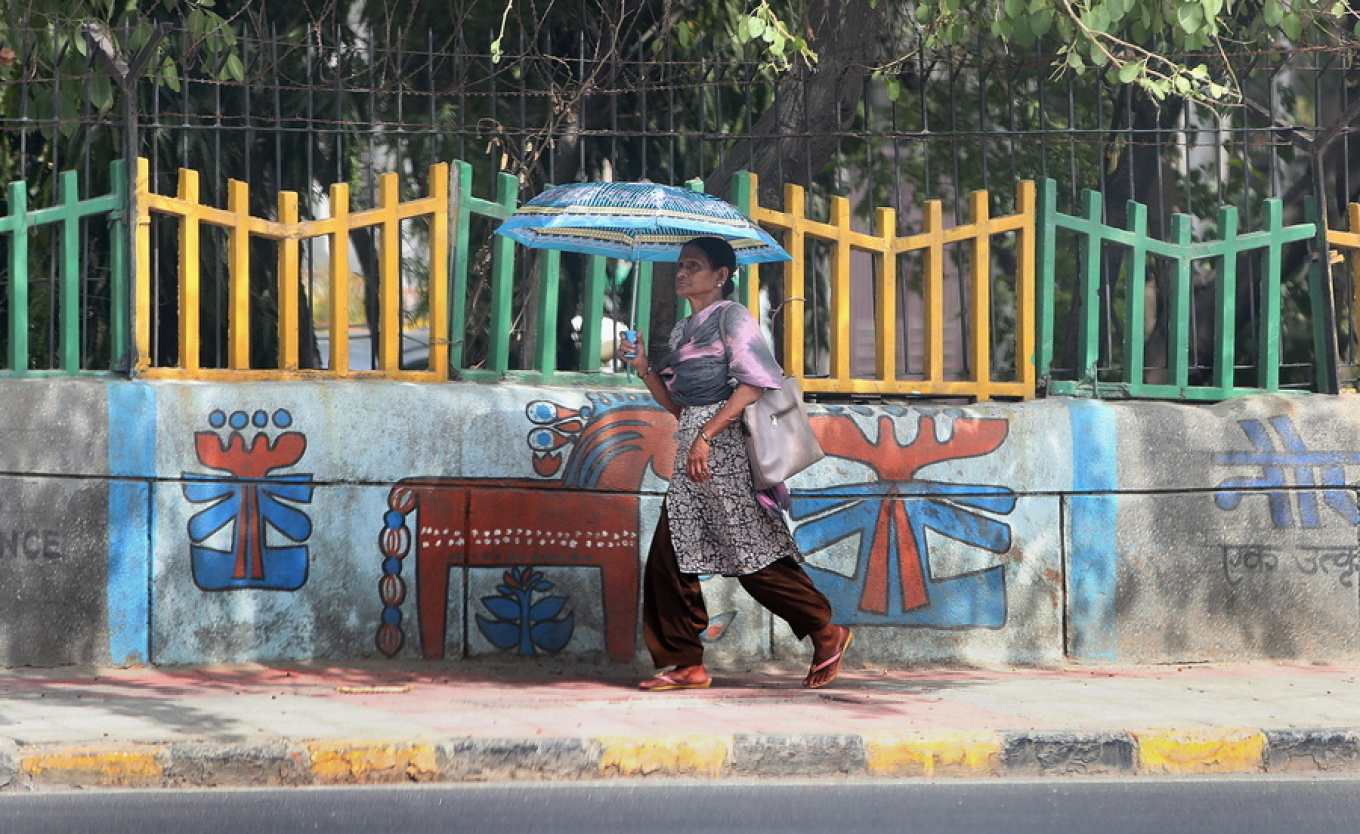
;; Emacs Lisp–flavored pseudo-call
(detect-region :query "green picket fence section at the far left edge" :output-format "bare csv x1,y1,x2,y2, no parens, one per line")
0,161,131,377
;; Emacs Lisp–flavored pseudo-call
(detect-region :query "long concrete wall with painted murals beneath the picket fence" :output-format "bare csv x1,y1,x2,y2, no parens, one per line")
0,380,1360,667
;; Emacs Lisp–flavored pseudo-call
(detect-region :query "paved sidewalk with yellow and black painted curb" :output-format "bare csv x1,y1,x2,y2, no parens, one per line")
0,661,1360,790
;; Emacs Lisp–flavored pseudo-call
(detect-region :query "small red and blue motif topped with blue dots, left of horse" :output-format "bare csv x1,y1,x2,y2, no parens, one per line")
184,410,313,590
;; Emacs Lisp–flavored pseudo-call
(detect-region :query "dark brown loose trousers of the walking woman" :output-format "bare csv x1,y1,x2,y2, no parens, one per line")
642,505,831,668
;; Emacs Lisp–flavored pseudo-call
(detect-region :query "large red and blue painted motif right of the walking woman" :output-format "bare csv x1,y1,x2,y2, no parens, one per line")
790,415,1016,629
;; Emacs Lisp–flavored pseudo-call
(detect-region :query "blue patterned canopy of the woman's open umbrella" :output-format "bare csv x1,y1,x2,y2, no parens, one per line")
496,182,792,264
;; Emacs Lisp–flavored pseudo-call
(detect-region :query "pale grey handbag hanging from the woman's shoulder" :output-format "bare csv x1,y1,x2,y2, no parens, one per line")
741,377,826,490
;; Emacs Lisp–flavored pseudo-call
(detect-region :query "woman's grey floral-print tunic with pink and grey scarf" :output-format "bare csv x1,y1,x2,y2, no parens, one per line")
656,301,802,576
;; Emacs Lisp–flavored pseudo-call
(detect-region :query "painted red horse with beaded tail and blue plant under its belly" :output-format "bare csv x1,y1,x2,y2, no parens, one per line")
377,393,675,663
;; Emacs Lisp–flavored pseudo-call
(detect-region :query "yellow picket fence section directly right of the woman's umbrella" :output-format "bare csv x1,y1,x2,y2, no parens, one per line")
734,173,1036,401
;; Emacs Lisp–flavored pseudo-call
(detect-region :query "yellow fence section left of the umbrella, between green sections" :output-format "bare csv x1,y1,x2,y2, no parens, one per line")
136,159,453,381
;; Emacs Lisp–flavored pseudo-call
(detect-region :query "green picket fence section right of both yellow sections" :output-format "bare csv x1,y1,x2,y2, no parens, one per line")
1036,180,1330,401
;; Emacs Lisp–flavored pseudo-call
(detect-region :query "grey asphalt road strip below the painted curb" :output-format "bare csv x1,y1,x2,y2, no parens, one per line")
0,777,1360,834
